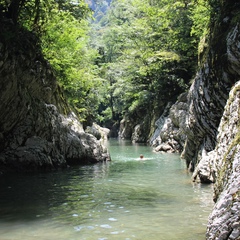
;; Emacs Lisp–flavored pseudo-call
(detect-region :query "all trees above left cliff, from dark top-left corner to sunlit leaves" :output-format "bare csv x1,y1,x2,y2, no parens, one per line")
0,0,99,124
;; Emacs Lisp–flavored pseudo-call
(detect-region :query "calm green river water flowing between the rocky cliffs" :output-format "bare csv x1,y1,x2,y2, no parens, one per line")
0,140,213,240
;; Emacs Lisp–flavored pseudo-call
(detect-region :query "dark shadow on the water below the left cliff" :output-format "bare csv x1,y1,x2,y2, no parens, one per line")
0,163,107,221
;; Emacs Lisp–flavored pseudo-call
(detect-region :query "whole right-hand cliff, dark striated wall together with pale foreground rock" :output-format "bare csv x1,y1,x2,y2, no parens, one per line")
150,0,240,240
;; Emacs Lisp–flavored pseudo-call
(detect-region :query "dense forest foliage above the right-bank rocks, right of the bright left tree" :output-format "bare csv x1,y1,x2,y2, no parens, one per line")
89,0,209,126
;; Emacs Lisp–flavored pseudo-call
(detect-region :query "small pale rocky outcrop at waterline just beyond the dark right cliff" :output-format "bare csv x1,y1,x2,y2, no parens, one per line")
150,93,188,152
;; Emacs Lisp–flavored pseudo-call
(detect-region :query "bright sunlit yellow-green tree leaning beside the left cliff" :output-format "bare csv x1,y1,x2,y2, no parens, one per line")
41,9,103,122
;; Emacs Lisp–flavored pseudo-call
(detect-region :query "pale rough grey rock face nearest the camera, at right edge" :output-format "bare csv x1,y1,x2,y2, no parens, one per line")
207,81,240,240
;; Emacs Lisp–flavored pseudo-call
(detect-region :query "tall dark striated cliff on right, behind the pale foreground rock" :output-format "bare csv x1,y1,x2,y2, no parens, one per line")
182,1,240,176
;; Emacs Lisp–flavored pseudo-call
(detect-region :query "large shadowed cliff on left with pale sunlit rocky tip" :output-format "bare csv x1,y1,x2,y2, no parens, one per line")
0,21,109,172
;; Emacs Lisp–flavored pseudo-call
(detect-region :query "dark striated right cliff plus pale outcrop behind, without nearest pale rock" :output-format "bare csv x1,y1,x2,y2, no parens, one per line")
151,1,240,182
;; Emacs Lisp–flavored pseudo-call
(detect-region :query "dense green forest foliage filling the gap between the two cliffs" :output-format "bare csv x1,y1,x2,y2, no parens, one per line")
0,0,210,129
